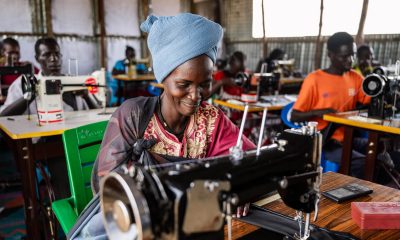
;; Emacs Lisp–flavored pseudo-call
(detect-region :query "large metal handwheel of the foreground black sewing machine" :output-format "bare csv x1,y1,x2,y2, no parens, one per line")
100,173,154,240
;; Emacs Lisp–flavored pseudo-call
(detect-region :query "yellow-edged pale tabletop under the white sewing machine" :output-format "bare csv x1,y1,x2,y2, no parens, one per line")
0,108,116,139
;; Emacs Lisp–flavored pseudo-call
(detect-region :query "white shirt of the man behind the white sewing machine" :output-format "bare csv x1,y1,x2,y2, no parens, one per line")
0,73,89,115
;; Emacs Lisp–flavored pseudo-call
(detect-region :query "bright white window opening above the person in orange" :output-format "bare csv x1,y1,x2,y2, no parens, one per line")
252,0,382,38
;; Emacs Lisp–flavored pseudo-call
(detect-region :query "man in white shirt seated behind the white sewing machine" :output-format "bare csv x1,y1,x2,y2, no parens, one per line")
0,38,99,116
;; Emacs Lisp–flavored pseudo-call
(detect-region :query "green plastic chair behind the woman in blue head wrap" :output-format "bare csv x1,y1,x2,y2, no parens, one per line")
52,121,108,234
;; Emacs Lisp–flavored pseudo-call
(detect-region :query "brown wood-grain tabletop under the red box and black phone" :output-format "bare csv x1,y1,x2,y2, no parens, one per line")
225,172,400,240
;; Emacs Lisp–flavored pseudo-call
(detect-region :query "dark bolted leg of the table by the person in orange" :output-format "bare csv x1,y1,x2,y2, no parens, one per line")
364,131,379,181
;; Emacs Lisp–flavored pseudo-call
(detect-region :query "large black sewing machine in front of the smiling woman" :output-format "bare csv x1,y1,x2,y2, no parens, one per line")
100,123,322,240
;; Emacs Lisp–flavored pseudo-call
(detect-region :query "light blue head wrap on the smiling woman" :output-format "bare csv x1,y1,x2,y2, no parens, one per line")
140,13,222,82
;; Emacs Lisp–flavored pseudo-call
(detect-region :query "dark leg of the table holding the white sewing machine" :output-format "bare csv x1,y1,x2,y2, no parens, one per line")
14,138,41,239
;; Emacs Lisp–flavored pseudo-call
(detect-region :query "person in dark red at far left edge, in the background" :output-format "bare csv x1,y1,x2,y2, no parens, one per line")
0,38,39,94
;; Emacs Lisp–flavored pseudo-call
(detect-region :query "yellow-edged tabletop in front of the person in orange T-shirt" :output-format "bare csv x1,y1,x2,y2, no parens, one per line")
323,111,400,134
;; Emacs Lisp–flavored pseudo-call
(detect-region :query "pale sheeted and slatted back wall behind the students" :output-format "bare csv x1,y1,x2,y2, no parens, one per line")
0,0,400,74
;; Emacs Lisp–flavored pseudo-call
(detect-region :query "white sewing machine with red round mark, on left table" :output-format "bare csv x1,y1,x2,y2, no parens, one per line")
22,69,106,124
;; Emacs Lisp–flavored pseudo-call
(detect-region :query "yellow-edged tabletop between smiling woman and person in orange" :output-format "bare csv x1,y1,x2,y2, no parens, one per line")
213,95,295,112
